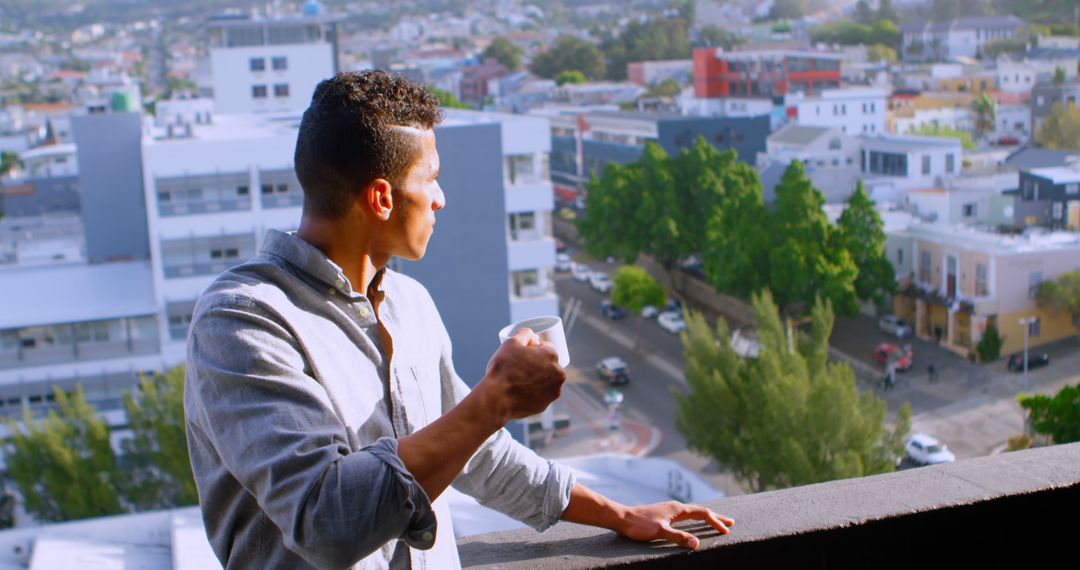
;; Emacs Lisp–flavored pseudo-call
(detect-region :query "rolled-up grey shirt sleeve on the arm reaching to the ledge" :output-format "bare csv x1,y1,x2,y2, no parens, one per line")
440,310,575,532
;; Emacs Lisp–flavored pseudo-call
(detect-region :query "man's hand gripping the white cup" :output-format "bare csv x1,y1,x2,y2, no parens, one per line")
473,328,566,424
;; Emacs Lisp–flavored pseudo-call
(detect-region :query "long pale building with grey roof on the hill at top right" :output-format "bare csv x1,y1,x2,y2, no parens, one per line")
900,14,1027,62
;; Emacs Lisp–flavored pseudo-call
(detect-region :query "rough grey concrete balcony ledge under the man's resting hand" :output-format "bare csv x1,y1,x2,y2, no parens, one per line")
458,443,1080,570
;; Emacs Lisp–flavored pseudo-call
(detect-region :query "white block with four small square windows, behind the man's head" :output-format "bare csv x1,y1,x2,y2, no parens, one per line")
206,10,338,113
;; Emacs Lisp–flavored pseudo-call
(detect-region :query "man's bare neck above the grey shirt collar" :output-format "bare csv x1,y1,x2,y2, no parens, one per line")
296,214,390,295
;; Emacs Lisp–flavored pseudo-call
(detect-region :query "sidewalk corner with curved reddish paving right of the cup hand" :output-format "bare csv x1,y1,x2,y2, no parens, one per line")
529,368,662,459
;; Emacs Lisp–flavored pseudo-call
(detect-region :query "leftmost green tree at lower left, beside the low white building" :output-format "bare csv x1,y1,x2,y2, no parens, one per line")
4,386,124,521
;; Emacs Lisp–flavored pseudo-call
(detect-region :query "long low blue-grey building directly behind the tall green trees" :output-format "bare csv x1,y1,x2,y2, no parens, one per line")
551,111,770,201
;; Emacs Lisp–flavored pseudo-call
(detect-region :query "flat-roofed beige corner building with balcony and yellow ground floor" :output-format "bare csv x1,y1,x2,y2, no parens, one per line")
888,225,1080,356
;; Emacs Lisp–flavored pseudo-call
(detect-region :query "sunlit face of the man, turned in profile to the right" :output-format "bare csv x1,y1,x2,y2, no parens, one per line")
383,128,446,261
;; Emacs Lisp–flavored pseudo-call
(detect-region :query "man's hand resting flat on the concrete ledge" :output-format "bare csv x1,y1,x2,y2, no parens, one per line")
612,501,735,549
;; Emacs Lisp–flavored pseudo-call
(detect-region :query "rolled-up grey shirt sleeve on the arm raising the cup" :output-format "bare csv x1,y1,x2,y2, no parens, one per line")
185,299,436,567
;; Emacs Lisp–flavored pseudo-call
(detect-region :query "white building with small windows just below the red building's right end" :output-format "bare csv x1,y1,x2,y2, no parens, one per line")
786,87,889,136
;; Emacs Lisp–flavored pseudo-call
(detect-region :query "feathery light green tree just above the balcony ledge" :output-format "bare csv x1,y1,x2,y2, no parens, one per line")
675,293,910,491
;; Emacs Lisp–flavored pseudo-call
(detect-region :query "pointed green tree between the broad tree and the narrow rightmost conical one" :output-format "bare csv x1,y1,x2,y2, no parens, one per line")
768,161,859,314
